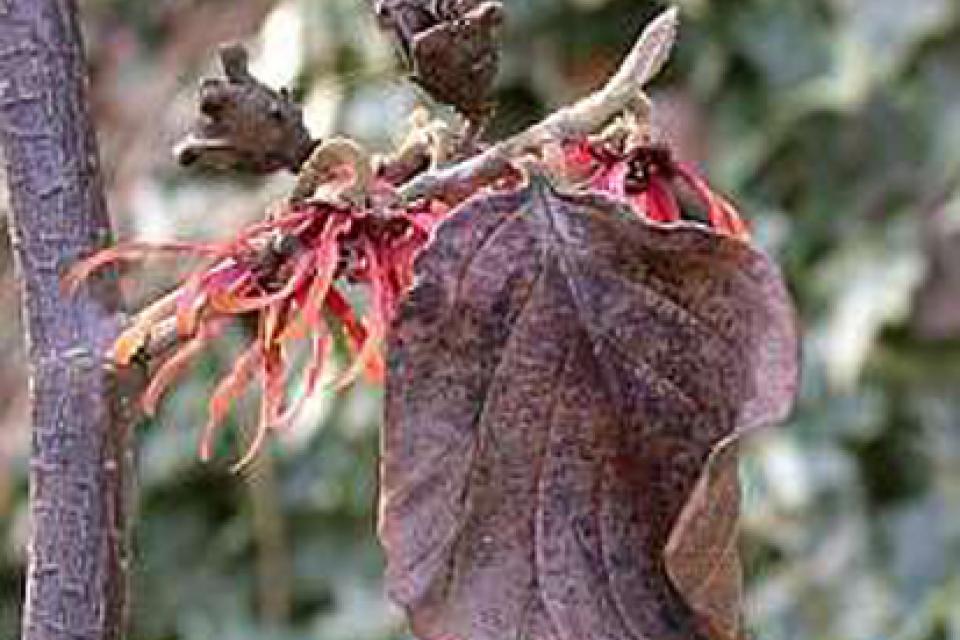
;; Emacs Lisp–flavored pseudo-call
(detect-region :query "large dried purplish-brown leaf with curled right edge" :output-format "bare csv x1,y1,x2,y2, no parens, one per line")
380,171,797,640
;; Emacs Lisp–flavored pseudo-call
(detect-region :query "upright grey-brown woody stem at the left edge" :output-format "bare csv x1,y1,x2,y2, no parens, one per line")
0,0,133,640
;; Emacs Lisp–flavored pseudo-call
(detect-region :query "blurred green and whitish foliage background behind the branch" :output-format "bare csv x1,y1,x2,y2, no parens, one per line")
0,0,960,640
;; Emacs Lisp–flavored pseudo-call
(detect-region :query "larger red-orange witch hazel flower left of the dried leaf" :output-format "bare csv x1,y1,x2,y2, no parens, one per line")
67,139,447,468
